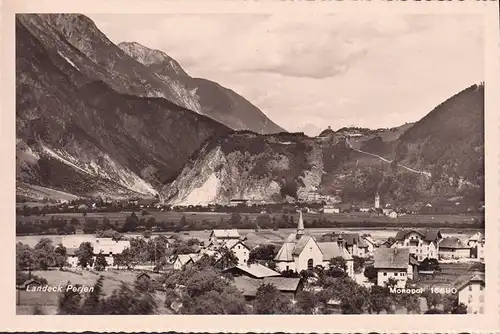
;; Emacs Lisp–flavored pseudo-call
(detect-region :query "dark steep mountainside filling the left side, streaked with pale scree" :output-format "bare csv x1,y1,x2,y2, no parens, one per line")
16,15,229,196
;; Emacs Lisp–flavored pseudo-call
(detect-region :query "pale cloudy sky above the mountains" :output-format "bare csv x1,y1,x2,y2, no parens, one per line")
88,14,484,135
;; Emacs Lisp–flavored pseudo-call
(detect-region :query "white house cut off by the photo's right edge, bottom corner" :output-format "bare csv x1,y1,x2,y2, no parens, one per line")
456,273,485,314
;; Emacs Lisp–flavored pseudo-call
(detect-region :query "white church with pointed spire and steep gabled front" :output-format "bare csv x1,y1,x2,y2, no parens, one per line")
274,211,354,277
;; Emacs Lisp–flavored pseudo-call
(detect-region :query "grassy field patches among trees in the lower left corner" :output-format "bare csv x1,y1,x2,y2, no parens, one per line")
16,270,166,314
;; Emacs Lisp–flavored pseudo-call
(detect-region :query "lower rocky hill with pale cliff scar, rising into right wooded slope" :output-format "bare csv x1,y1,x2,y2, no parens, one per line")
160,85,484,205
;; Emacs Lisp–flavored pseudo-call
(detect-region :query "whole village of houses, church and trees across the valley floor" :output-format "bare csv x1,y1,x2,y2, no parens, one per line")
16,200,485,314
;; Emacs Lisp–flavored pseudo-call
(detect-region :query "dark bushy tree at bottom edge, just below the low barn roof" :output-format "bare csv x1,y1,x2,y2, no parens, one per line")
253,284,291,314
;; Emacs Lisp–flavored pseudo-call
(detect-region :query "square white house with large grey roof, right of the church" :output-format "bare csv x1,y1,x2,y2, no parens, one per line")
373,248,419,288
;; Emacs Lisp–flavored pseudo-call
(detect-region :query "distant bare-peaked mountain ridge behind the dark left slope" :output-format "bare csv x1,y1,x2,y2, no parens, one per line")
118,42,283,134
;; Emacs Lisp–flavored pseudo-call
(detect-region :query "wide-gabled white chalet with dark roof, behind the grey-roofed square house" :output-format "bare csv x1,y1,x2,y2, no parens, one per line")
391,229,443,261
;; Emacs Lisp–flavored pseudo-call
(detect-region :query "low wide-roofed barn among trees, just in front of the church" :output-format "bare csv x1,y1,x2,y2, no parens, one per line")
234,276,302,301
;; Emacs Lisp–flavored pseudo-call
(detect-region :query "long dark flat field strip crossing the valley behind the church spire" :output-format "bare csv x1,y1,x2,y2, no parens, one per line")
16,209,484,227
